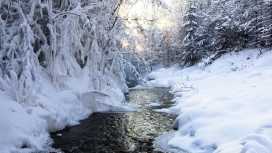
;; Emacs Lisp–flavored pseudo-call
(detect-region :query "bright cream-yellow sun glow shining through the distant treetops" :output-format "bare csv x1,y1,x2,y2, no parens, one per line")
119,0,172,52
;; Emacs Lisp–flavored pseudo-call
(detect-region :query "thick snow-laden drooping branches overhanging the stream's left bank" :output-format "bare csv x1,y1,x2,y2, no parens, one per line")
0,0,127,105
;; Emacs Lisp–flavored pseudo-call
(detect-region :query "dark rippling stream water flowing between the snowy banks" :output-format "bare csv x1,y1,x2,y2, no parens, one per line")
51,88,176,153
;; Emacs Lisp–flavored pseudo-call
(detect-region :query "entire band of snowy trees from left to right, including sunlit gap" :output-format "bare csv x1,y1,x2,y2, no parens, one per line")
0,0,272,102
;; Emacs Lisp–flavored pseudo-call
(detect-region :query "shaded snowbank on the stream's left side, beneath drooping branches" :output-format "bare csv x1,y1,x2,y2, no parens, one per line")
0,69,133,153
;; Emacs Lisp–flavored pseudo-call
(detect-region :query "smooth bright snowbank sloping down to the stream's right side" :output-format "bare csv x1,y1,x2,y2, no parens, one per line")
150,50,272,153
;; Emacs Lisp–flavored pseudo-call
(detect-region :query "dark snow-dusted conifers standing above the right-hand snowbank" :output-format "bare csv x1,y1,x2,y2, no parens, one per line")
173,0,272,66
